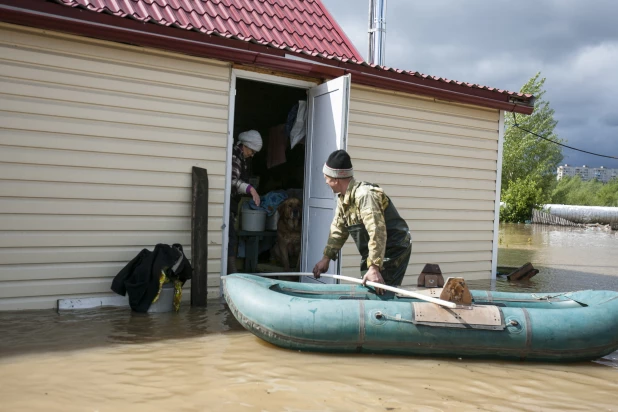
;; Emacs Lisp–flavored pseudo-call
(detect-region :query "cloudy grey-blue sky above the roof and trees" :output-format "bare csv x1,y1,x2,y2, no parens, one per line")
322,0,618,168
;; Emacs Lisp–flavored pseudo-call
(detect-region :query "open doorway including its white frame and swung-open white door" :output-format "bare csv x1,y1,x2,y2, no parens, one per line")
222,71,351,283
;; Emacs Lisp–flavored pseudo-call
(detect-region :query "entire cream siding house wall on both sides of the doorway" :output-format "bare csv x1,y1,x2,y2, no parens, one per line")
0,24,499,310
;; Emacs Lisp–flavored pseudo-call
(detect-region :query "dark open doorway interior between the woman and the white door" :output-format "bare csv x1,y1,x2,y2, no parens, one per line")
228,78,307,280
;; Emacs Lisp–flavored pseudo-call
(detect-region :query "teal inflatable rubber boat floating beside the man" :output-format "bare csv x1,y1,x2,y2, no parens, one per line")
223,274,618,362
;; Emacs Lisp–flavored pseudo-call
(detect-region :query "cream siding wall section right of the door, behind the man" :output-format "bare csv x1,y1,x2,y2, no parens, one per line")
342,84,500,285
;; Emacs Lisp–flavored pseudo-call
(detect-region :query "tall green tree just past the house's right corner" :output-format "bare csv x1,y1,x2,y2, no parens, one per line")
500,73,563,222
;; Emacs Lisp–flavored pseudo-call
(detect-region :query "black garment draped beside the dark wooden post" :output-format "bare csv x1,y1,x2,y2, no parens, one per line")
111,243,193,312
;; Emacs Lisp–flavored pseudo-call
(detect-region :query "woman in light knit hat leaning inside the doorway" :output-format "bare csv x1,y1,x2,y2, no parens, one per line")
227,130,262,275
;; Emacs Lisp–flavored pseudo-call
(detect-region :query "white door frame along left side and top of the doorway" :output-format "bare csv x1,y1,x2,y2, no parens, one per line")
219,68,320,286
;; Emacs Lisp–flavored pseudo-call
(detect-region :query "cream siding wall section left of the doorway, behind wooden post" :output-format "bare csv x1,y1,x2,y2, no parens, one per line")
0,25,231,310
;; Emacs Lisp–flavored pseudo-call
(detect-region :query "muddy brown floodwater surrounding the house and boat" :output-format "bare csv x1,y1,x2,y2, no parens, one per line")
0,225,618,412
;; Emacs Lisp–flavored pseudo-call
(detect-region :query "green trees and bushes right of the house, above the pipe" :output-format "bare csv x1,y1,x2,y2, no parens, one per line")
500,73,618,222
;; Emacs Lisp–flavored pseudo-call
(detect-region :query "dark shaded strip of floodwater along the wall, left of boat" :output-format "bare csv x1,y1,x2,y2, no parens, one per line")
0,301,245,357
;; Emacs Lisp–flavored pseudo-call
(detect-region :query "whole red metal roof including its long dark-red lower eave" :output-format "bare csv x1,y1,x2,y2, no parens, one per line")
0,0,535,109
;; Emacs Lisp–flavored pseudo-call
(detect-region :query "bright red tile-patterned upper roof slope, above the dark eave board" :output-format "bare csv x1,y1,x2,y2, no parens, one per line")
56,0,362,61
